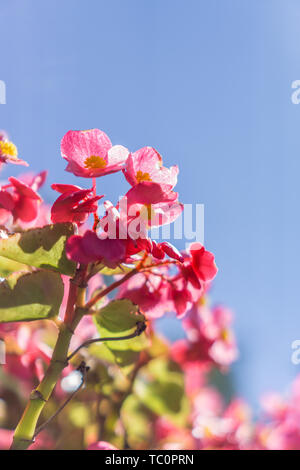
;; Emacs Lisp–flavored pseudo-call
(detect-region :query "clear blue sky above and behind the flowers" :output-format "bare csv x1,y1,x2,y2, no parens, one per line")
0,0,300,410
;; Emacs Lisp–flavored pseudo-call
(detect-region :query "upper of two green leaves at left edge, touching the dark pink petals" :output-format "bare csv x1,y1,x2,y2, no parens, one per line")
0,224,76,276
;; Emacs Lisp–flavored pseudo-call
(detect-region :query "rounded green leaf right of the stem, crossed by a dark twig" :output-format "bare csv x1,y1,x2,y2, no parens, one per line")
93,299,148,367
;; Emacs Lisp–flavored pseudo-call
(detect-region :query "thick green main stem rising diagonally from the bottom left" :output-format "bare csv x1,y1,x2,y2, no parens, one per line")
11,289,85,450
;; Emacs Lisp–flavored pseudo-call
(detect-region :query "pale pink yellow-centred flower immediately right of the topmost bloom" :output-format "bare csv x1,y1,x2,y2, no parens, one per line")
123,147,179,189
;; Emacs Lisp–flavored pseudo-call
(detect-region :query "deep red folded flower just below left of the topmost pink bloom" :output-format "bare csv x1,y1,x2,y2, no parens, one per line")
51,184,103,224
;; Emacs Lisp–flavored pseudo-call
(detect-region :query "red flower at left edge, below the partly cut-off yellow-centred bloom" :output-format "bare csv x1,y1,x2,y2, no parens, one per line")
0,176,41,224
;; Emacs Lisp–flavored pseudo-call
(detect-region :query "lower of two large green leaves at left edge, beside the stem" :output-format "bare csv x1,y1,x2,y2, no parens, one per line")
0,271,64,323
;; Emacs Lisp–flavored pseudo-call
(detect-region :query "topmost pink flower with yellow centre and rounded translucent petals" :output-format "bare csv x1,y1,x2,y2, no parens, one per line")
61,129,129,178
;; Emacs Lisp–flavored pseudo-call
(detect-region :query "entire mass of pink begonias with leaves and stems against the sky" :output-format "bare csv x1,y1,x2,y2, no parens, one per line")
0,129,294,451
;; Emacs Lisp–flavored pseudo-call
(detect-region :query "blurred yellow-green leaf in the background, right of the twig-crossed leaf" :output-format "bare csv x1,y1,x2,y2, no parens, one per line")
134,358,189,426
